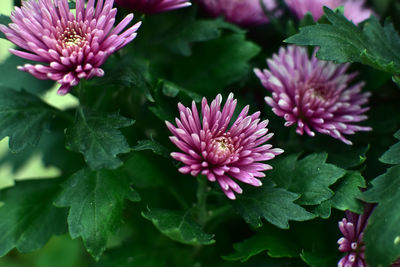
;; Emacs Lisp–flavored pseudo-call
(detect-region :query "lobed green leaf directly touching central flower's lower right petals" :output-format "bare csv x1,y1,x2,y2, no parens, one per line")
232,182,315,229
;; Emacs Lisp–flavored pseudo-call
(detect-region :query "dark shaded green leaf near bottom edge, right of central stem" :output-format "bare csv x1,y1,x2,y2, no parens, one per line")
222,232,300,262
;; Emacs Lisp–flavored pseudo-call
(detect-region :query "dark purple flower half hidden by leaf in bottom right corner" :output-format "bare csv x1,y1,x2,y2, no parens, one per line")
337,204,374,267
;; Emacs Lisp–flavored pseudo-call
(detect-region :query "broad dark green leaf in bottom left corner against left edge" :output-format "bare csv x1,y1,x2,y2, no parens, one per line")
0,180,67,256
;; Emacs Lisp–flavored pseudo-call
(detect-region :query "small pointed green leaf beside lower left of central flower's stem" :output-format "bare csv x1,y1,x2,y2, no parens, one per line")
142,209,215,245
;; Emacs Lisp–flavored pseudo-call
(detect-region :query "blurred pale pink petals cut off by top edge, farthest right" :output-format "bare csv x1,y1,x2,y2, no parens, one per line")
285,0,373,24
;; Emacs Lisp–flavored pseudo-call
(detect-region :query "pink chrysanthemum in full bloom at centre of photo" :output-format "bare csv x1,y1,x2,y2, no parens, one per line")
166,93,283,199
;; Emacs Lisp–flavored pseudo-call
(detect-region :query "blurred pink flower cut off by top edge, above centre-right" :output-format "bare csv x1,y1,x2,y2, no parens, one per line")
198,0,280,27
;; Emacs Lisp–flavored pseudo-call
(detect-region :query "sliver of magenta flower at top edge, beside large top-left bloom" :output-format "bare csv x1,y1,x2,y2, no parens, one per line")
115,0,192,14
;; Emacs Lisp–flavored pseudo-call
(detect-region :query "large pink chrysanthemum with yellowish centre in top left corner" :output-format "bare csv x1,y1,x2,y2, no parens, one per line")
0,0,140,95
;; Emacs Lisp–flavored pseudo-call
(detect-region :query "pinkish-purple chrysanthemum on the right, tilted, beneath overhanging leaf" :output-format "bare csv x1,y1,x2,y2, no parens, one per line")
254,46,372,145
